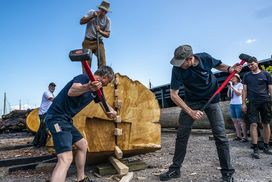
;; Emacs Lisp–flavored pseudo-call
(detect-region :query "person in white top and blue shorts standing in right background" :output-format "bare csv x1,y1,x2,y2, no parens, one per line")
227,73,248,142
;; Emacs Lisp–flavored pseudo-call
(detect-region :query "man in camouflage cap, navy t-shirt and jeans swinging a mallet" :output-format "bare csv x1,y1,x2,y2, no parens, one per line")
160,45,242,182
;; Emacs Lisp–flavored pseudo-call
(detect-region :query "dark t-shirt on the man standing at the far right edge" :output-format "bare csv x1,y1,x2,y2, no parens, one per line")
242,71,272,103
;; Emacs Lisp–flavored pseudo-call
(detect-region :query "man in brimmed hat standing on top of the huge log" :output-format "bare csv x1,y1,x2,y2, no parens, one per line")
80,1,111,70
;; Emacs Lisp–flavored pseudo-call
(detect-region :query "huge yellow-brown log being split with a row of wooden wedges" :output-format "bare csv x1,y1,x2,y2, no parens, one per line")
27,74,161,161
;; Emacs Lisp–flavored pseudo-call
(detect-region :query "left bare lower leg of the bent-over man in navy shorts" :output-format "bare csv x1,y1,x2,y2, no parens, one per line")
51,151,73,182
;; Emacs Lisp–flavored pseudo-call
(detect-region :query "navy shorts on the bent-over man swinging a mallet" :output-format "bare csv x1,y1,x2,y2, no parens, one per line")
46,118,83,154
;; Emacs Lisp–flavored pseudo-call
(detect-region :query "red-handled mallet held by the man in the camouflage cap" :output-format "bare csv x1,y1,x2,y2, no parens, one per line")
201,54,252,111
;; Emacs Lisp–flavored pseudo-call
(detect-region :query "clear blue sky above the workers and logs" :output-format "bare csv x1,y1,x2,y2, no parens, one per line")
0,0,272,114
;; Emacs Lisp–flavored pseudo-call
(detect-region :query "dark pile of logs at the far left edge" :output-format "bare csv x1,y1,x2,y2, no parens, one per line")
0,109,32,133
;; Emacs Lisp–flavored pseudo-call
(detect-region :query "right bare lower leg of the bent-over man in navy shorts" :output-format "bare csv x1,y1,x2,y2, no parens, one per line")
75,138,88,181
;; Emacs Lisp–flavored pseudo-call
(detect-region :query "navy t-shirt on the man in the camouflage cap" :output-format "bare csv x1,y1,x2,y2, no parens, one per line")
171,53,222,103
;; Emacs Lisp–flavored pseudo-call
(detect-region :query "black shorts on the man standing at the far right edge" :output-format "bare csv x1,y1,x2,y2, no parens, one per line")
247,102,271,124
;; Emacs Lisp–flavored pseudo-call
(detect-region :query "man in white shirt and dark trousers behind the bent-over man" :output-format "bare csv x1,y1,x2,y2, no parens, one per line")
33,82,56,147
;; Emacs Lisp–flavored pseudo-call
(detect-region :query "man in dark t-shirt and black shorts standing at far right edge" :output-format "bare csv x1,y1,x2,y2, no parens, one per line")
242,57,272,159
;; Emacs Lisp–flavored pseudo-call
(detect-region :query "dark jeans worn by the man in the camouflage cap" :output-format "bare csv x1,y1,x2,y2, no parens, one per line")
169,103,235,176
